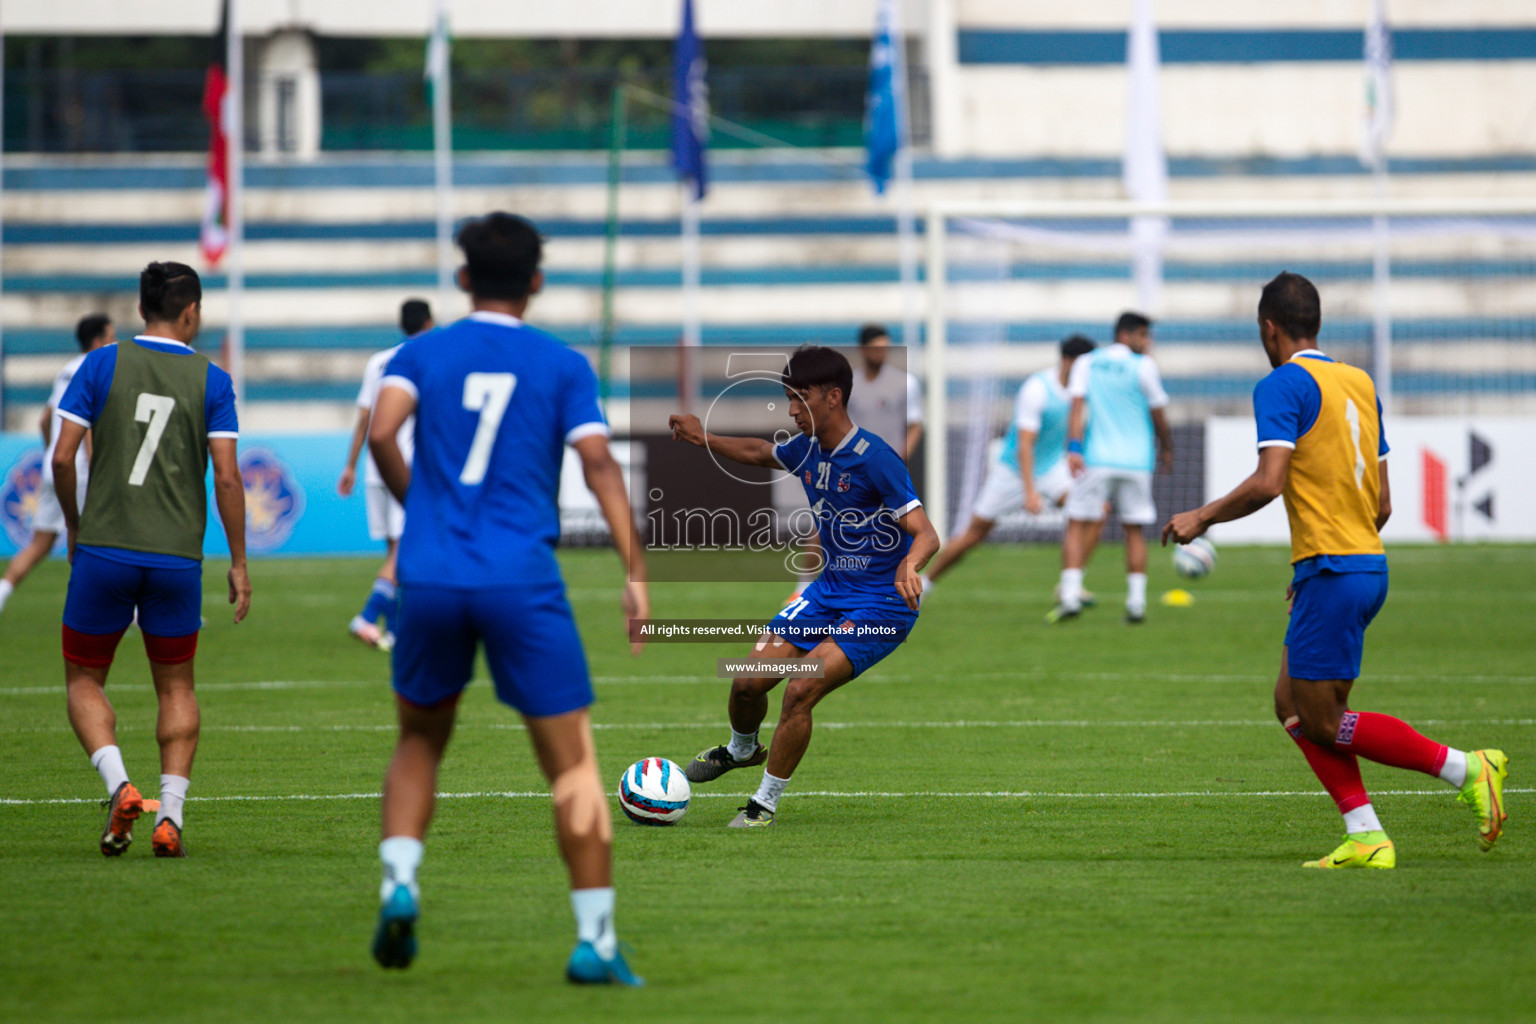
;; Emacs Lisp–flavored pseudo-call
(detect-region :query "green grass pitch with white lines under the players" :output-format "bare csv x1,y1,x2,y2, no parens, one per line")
0,547,1536,1024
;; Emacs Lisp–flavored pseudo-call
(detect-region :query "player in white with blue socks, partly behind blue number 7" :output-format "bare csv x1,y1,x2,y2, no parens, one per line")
336,299,433,651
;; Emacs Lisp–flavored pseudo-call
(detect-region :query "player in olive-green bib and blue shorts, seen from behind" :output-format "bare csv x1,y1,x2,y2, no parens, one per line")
54,263,250,857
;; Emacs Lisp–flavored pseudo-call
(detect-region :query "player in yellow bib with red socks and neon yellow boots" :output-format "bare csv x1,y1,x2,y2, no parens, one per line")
1163,272,1508,867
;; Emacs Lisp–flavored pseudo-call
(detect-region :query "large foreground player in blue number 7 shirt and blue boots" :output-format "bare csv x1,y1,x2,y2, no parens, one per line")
369,213,648,986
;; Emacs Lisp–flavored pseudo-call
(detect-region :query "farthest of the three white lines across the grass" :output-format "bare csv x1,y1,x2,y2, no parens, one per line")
0,666,1536,697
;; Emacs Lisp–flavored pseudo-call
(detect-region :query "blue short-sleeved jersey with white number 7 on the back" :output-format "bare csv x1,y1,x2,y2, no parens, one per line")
379,312,608,590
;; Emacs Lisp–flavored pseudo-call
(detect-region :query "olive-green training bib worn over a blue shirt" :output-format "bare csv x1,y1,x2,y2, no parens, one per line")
78,341,209,560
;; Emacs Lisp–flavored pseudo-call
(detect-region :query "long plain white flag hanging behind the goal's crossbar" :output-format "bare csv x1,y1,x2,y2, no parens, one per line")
1121,0,1167,313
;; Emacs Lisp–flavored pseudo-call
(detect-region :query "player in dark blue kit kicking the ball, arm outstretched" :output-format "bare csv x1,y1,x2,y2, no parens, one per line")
670,347,938,827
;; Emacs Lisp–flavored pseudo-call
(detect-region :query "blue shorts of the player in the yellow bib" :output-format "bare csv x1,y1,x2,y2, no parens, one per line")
1286,571,1387,679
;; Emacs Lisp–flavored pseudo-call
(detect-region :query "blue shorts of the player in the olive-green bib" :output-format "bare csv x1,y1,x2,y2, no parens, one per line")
65,547,203,637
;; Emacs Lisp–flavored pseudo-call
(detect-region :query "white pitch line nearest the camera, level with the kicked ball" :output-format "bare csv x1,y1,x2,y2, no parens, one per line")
0,786,1536,808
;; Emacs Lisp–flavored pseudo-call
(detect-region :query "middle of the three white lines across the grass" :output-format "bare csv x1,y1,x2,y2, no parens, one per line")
11,718,1536,732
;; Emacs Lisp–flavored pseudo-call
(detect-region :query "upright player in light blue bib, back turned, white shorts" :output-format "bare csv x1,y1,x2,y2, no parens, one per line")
1046,313,1174,623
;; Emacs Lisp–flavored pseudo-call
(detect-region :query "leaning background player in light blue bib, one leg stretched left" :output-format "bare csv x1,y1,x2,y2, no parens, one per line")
923,335,1094,590
